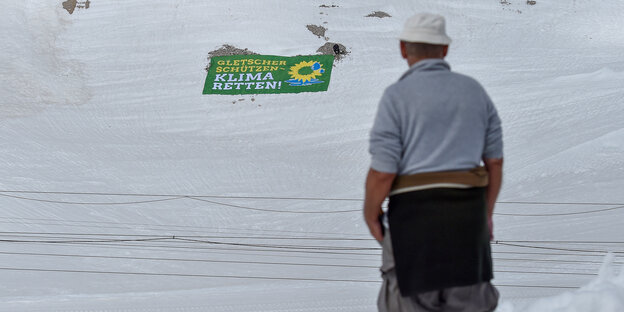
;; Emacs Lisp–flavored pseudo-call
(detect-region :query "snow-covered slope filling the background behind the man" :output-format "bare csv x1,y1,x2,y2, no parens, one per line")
0,0,624,312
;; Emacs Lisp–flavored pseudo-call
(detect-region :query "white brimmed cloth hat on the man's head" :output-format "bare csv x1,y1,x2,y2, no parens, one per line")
399,13,451,45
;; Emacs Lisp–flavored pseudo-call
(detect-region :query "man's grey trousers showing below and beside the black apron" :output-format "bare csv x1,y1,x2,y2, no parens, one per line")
377,229,499,312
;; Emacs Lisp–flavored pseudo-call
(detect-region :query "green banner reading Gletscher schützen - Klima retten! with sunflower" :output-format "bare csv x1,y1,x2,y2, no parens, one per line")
203,55,334,94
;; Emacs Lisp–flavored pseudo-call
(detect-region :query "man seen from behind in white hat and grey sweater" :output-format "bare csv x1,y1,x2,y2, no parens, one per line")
364,13,503,312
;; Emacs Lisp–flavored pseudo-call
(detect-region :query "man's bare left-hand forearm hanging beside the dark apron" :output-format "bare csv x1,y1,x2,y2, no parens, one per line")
364,168,396,242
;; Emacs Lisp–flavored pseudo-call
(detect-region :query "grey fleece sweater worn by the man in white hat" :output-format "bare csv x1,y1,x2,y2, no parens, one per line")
369,59,503,175
